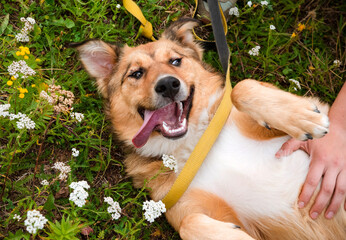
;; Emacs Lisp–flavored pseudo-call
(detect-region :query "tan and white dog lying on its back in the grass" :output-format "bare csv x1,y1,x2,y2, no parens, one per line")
77,19,346,240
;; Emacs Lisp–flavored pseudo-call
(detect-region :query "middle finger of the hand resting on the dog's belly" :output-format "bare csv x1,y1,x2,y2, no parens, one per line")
310,168,339,219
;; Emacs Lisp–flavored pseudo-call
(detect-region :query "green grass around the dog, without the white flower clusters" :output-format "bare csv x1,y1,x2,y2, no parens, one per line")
0,0,346,239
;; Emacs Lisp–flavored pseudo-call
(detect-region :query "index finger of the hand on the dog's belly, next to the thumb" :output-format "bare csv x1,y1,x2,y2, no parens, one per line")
298,163,324,208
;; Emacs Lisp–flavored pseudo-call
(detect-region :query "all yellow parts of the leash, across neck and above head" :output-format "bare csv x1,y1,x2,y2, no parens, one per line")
123,0,232,209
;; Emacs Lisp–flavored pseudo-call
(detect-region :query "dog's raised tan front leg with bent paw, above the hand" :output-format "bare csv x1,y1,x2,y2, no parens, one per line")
232,79,329,140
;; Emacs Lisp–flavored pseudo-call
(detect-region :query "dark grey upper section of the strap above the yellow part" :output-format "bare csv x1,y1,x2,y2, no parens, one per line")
208,0,229,73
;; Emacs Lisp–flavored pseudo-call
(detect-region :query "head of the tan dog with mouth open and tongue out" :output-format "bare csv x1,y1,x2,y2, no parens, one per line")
77,19,223,158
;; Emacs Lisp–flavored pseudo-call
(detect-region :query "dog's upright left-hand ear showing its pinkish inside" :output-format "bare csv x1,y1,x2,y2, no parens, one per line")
71,40,119,98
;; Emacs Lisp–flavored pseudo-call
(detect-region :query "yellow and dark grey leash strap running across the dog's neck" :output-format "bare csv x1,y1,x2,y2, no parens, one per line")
162,0,232,209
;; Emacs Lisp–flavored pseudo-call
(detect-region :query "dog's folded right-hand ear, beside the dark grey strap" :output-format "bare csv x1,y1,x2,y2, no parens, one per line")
162,18,203,60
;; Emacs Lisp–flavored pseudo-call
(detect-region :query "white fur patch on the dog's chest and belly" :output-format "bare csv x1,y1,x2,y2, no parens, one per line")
190,124,309,220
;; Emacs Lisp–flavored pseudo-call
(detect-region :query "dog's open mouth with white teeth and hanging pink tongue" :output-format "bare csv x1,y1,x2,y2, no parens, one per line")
132,87,194,148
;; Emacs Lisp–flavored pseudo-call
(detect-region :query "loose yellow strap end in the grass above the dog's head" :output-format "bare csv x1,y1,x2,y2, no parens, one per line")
123,0,156,41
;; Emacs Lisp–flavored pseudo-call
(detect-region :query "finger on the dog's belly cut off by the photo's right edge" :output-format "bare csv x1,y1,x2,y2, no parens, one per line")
325,171,346,219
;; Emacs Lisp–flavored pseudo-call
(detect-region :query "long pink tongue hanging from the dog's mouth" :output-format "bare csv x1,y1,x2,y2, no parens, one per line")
132,102,177,148
